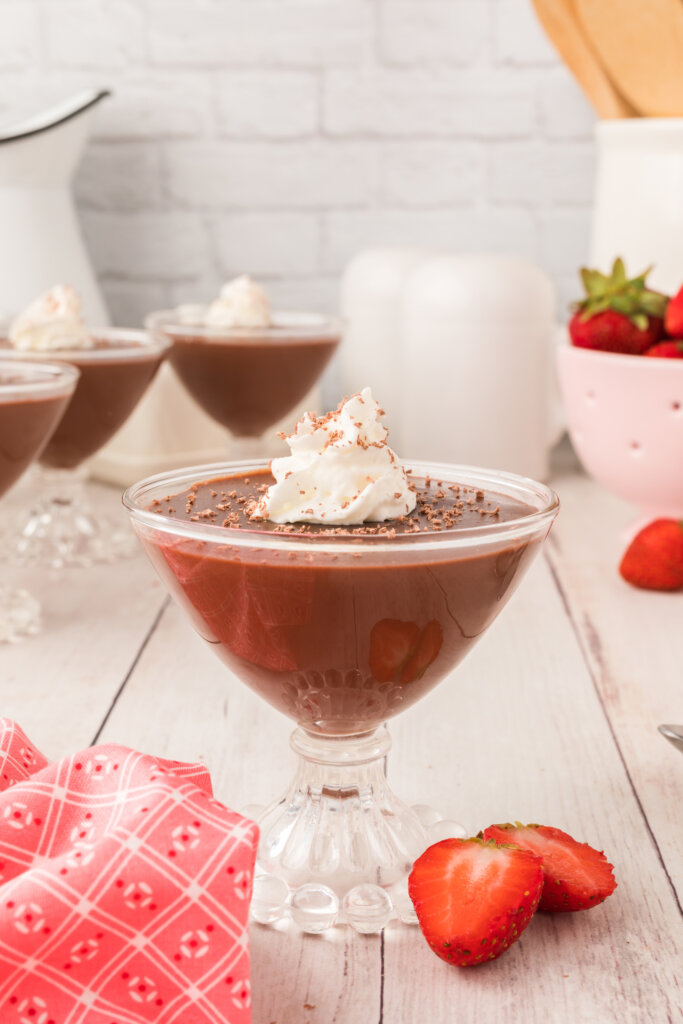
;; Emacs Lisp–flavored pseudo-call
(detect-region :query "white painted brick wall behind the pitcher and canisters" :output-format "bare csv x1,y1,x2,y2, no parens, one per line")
0,0,594,323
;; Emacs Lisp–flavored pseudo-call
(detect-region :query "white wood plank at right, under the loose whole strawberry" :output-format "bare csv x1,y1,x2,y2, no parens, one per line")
548,474,683,903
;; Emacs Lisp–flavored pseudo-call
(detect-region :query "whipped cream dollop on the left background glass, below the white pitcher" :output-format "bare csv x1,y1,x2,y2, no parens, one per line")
8,285,95,352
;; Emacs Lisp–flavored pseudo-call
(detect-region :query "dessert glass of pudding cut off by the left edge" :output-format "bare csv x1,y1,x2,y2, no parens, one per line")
0,358,79,642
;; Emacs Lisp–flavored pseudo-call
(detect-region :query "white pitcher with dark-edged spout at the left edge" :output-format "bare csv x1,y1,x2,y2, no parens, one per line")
0,90,109,326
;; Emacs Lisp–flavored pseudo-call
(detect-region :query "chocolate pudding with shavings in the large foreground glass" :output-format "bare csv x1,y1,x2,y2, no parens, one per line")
138,471,549,735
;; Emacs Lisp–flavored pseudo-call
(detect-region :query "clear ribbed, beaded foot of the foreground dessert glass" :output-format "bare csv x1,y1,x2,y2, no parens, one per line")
245,726,466,934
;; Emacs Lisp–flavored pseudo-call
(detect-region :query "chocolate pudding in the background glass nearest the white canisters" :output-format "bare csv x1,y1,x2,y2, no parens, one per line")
146,313,340,437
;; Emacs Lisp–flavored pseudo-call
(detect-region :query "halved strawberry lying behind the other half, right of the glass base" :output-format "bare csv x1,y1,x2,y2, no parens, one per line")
482,821,616,912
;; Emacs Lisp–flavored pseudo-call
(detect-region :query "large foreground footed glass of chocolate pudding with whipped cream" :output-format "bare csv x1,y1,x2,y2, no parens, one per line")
124,389,558,900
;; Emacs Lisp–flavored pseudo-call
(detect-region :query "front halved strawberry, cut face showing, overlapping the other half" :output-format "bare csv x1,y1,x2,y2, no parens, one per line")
408,839,543,967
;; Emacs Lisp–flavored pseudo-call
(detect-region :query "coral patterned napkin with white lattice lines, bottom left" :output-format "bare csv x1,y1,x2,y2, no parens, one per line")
0,719,258,1024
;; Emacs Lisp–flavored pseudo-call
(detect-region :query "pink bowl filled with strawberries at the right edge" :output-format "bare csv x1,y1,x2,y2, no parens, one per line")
558,259,683,561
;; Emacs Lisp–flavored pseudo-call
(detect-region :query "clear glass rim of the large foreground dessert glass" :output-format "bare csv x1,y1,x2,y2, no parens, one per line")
122,459,559,554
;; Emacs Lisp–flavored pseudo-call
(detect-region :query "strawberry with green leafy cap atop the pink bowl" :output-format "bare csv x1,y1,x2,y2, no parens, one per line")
569,259,669,355
